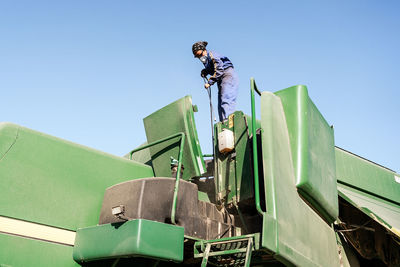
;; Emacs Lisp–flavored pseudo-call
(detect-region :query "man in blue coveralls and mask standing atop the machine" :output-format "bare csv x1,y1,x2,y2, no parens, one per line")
192,41,239,121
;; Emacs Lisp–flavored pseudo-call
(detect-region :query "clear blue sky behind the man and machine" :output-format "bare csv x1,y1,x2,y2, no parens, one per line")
0,0,400,172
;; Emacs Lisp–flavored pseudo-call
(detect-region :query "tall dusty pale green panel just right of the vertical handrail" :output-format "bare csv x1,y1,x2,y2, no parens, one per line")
261,92,339,267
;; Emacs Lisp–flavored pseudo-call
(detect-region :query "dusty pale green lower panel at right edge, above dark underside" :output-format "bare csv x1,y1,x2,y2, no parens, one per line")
338,184,400,237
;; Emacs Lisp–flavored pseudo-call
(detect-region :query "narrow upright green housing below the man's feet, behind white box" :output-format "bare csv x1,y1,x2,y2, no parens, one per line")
214,111,260,203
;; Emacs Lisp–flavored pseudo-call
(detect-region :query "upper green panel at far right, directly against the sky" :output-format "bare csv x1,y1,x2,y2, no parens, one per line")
335,148,400,205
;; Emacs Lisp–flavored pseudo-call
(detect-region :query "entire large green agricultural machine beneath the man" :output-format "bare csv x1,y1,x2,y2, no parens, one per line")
0,79,400,267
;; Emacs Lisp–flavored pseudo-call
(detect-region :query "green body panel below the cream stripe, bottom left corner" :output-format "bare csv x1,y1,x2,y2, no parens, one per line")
0,233,80,267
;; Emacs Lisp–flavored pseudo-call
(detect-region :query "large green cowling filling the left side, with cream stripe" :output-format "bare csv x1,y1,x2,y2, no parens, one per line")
0,123,153,267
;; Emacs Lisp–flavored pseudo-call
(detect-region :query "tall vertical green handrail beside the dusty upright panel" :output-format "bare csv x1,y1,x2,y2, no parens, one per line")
250,78,264,215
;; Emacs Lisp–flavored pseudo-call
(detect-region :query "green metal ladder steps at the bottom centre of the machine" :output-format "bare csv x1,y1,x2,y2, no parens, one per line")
194,235,254,267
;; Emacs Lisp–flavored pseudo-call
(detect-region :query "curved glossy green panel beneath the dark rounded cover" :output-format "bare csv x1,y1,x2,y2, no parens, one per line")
73,219,184,262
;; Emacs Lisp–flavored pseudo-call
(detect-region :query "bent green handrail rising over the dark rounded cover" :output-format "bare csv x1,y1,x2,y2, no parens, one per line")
129,132,185,224
